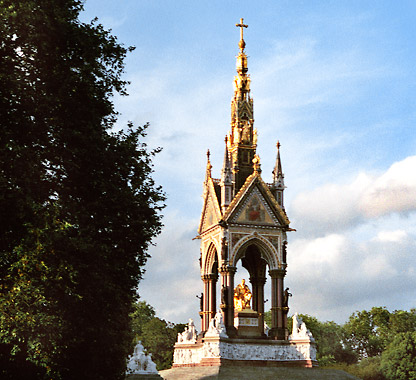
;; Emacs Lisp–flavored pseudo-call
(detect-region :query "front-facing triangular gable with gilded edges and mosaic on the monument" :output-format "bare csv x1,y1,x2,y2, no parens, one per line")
224,172,290,227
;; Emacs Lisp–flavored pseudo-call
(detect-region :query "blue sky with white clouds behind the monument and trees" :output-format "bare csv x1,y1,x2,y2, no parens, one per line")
81,0,416,323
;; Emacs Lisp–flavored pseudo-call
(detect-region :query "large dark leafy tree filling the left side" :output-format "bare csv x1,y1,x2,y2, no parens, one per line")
0,0,164,379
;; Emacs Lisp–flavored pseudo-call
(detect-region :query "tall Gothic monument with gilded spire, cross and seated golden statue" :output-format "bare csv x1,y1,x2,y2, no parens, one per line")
174,19,316,367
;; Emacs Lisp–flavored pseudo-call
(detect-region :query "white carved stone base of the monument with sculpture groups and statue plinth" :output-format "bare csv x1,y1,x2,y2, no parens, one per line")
173,309,317,368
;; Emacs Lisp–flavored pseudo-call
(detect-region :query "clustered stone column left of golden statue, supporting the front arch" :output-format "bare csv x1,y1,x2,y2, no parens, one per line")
220,265,237,337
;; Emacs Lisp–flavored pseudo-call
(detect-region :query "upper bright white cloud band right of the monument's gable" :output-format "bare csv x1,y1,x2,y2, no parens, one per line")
290,156,416,234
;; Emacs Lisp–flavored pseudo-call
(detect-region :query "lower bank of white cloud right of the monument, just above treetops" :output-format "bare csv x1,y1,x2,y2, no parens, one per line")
286,230,416,323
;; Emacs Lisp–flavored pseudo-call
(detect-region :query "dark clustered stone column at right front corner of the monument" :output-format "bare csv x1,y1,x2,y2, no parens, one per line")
269,269,287,339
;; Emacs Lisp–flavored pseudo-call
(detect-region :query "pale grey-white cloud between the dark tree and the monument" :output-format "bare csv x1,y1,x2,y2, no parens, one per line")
139,211,201,323
